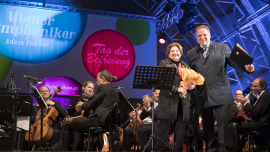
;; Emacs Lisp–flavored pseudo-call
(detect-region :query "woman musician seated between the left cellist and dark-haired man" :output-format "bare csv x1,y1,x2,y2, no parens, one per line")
72,81,95,151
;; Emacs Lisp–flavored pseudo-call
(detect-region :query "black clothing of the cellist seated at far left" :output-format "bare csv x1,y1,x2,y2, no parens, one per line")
33,101,67,146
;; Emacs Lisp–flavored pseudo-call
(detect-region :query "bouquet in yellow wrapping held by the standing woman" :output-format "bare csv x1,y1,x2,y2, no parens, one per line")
179,67,204,98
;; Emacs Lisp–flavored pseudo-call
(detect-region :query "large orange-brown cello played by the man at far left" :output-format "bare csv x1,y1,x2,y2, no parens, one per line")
25,86,62,146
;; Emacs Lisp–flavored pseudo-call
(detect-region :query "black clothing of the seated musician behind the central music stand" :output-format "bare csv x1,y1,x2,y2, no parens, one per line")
122,102,159,150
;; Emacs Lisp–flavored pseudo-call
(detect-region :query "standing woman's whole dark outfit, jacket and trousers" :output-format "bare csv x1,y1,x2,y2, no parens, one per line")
155,59,195,151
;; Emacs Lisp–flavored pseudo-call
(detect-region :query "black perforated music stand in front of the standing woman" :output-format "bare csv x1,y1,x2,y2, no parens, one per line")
132,65,176,152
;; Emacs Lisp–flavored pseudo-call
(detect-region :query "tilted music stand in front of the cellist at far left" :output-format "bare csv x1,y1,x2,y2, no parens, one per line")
29,84,48,150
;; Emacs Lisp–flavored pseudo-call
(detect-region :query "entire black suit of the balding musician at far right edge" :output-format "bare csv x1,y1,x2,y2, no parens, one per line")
239,91,270,133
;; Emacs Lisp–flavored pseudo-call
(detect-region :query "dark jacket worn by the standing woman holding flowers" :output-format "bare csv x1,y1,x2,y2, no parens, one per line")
157,59,195,121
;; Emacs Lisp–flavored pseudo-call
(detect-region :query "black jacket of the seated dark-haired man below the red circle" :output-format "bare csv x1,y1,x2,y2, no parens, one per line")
82,84,119,126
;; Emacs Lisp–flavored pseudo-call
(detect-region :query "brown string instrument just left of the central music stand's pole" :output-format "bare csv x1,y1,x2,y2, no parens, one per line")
128,103,142,149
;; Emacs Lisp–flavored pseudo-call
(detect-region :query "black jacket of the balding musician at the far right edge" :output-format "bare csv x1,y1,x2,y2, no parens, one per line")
242,91,270,127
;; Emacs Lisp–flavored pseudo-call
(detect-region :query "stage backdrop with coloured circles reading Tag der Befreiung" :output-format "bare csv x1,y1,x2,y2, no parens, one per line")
0,5,157,106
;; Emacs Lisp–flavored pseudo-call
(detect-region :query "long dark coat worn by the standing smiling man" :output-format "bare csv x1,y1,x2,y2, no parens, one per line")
187,41,245,108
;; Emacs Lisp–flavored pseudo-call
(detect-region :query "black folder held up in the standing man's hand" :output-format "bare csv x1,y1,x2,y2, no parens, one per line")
230,43,254,71
